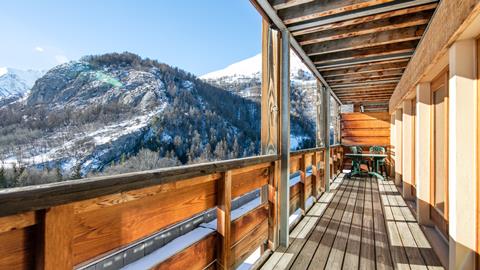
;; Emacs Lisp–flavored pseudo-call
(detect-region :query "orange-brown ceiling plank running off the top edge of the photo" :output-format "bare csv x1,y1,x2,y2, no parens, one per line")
278,0,393,25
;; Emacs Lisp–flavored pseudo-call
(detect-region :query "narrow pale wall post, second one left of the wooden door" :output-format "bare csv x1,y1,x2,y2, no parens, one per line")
402,99,415,200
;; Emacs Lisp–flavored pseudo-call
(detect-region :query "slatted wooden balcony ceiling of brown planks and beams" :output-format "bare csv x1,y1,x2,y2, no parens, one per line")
255,0,439,109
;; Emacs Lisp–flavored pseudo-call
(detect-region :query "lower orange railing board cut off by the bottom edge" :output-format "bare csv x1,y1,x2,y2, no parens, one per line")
153,233,217,270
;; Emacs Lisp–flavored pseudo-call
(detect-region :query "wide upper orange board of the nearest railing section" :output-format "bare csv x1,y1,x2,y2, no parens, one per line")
73,181,217,264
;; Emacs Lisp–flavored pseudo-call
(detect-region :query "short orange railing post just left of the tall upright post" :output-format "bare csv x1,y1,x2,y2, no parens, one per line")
217,171,232,269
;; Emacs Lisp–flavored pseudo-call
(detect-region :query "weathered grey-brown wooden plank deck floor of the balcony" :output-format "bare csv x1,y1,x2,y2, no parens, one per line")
262,177,443,270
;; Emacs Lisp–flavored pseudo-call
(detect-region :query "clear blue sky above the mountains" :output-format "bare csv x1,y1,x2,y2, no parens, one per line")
0,0,261,75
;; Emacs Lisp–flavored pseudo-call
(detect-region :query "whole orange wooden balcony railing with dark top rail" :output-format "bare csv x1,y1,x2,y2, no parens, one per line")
0,147,341,269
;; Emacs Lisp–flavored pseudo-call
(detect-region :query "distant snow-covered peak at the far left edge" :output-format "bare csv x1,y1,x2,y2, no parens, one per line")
0,67,45,101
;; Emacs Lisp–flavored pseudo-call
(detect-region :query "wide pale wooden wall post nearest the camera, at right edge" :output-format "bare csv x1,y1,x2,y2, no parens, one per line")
446,39,478,269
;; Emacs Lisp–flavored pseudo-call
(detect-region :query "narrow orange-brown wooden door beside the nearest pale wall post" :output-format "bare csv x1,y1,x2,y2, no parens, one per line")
430,70,448,239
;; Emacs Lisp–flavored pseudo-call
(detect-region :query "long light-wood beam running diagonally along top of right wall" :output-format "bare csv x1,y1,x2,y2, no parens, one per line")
389,0,480,112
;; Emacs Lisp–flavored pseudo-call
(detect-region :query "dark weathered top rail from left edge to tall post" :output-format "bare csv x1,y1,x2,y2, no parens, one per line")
0,155,278,216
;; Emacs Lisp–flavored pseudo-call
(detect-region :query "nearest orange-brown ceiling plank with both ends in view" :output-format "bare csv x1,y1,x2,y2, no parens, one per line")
297,10,433,46
